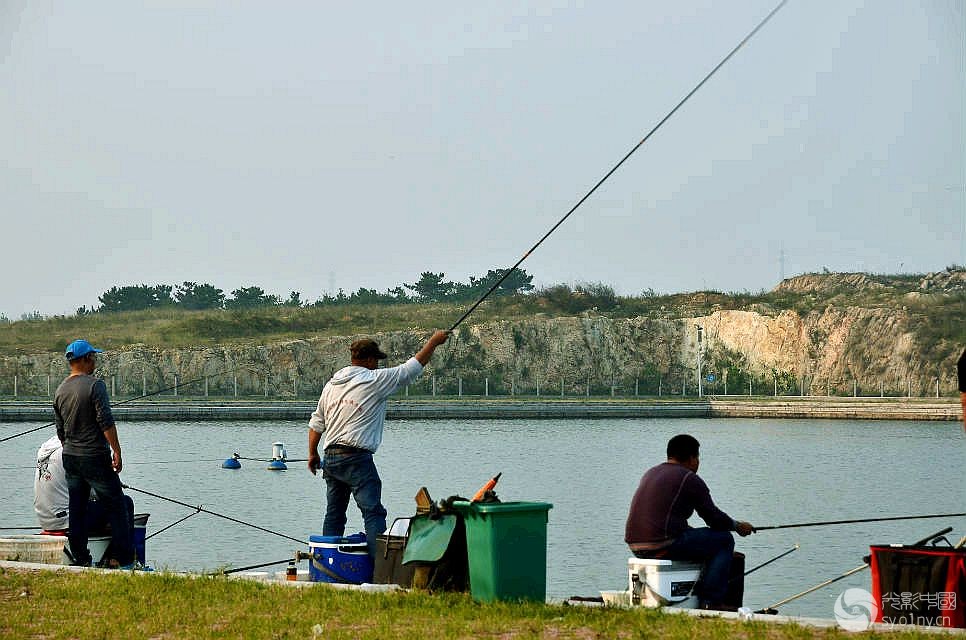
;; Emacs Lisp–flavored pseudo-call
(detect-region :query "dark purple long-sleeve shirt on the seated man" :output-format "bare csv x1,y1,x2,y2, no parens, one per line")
624,462,735,551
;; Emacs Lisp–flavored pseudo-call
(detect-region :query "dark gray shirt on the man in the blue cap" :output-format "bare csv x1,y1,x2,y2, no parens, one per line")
54,375,114,456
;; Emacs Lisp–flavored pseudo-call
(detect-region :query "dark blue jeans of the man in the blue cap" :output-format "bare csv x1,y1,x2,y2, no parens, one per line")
63,453,134,565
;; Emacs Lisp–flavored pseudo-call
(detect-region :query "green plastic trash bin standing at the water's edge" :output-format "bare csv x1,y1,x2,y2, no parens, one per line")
453,501,553,602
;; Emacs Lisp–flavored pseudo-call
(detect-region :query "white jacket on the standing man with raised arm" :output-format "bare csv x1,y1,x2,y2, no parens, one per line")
309,358,423,453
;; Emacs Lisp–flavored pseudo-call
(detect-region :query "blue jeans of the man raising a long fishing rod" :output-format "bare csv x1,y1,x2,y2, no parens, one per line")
322,453,386,558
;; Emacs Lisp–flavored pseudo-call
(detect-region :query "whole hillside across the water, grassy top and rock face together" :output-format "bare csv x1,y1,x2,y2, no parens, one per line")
0,268,966,398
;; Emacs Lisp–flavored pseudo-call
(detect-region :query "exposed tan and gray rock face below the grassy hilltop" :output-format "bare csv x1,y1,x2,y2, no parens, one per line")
0,302,962,399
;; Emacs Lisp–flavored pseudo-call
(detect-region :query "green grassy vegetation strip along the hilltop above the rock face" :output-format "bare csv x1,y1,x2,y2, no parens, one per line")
0,267,966,355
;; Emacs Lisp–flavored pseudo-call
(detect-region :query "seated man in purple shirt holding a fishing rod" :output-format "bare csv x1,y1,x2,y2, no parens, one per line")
624,435,755,609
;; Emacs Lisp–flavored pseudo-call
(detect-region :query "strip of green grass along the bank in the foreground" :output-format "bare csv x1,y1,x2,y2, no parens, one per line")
0,569,934,640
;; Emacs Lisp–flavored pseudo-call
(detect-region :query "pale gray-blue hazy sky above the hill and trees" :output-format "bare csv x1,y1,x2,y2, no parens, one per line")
0,0,966,320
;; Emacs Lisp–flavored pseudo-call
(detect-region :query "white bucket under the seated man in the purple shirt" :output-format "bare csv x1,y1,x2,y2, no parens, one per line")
627,558,701,609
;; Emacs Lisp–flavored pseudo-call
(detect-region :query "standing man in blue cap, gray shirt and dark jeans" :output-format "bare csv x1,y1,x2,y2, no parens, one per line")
54,340,134,568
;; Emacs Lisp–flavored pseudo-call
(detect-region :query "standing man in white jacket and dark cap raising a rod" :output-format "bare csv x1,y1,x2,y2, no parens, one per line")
308,331,450,557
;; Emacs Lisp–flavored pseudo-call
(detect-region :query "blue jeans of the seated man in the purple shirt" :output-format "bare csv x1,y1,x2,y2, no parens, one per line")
661,527,735,605
